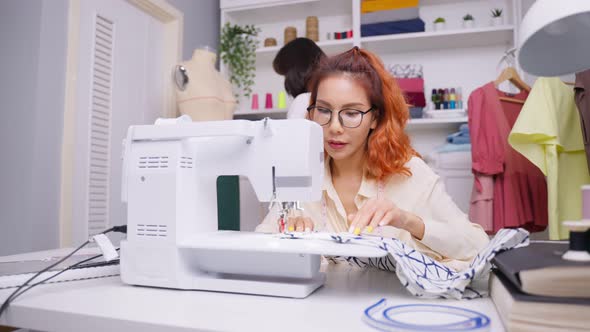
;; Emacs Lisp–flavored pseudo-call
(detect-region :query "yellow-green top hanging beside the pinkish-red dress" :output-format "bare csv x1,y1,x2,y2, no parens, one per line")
508,77,590,240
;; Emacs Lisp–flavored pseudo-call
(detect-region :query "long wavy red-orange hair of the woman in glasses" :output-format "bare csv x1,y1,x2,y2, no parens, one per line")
310,46,418,179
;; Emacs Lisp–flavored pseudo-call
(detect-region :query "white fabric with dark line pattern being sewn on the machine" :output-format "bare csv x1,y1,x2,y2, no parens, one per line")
278,228,529,299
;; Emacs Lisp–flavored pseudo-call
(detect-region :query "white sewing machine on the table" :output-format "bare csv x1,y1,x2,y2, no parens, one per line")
121,119,385,298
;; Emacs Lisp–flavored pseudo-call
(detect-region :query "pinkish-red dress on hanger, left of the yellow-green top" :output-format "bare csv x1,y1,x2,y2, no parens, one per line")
468,82,547,233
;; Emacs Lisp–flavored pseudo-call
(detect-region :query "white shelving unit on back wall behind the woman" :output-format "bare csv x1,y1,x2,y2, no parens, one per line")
221,0,532,220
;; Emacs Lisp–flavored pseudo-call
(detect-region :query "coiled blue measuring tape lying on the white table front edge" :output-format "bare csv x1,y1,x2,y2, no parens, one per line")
363,299,490,331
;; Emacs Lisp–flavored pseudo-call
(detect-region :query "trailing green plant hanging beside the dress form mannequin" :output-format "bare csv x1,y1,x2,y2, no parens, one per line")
219,22,258,99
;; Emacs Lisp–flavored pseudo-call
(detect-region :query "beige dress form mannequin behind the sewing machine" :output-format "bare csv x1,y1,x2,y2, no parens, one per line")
176,48,236,121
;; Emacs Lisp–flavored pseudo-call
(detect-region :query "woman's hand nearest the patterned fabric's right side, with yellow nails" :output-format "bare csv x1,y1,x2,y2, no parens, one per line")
348,198,424,240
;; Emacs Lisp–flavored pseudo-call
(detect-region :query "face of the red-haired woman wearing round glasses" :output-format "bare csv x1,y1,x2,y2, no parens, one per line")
309,74,376,161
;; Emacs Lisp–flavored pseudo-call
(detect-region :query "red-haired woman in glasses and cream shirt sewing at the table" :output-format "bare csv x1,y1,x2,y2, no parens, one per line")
257,47,488,270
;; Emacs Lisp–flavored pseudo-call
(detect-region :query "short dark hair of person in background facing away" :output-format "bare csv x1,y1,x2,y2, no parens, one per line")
272,38,326,97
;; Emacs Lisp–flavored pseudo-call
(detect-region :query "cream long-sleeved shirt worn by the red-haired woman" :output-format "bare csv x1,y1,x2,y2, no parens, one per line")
256,157,489,270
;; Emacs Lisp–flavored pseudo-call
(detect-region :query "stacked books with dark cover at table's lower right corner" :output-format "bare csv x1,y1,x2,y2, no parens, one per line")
490,241,590,331
